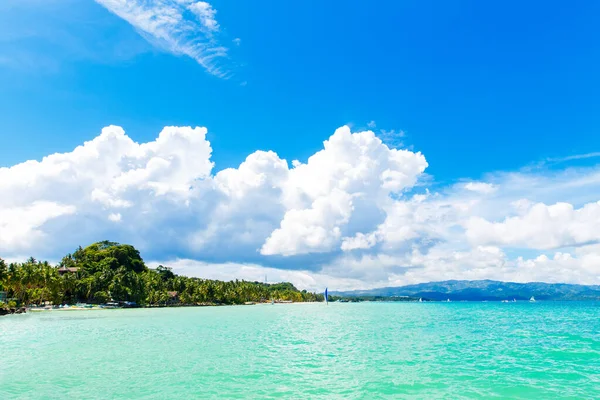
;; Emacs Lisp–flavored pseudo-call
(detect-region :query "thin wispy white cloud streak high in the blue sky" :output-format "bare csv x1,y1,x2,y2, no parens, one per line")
96,0,228,78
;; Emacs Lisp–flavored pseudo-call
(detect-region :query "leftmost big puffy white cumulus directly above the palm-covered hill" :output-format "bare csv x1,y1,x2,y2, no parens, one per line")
0,126,213,256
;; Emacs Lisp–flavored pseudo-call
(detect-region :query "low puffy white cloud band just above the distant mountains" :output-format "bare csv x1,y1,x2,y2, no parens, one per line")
319,241,600,289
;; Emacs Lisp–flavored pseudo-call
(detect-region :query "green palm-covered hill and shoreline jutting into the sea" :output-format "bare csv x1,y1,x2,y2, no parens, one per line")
0,241,323,305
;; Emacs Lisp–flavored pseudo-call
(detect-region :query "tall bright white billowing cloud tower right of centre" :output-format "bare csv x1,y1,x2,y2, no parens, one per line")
261,127,427,255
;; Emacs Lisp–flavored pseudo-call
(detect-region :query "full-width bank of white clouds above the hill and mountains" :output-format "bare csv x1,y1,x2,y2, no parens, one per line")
0,123,600,290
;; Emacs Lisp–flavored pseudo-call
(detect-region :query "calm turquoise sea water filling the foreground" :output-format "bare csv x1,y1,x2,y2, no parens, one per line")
0,302,600,399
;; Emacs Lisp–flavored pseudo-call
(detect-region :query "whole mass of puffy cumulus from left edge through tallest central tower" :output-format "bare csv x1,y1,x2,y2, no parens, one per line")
0,126,427,258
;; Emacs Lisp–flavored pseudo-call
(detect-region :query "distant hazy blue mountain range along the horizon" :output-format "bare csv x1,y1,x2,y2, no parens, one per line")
332,280,600,301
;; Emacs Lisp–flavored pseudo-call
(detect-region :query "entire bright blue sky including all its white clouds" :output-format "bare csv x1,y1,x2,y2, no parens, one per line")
0,0,600,290
